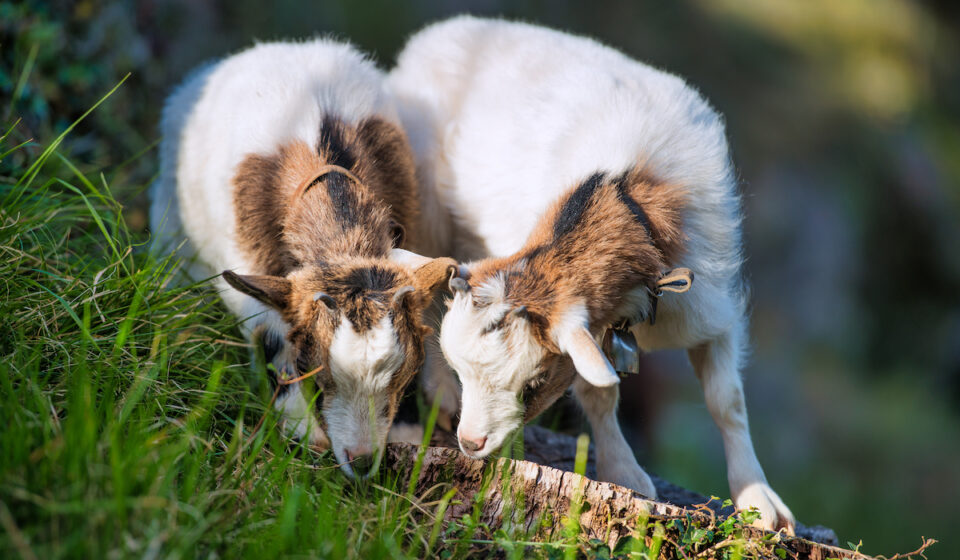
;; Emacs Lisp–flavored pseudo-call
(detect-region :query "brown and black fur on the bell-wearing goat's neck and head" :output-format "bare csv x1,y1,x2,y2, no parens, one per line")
469,166,686,340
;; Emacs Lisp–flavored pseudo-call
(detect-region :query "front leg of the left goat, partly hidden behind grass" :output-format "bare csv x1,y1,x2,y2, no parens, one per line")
262,331,330,451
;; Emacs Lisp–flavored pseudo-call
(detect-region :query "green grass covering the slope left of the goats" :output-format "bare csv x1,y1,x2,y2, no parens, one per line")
0,94,472,558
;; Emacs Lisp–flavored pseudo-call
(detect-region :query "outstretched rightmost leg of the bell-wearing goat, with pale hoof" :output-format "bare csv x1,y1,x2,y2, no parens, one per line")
687,329,796,535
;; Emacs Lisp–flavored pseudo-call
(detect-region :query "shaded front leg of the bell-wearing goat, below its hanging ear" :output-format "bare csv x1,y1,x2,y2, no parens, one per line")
573,375,657,500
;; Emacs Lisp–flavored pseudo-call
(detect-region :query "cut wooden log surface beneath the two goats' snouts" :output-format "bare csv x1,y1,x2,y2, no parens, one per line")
384,426,870,560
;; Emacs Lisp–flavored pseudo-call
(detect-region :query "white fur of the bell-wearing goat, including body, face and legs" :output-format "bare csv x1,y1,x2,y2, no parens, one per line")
388,17,793,528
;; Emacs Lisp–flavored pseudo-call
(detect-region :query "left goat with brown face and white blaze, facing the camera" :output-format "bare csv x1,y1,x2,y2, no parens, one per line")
151,40,456,476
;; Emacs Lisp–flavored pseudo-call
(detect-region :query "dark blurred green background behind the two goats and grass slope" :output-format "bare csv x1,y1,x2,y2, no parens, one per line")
0,0,960,558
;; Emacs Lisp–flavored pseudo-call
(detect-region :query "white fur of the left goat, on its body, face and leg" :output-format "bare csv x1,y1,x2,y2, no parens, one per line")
150,39,414,471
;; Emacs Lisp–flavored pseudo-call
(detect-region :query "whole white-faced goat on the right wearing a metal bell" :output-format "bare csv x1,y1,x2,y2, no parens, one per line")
388,17,794,531
